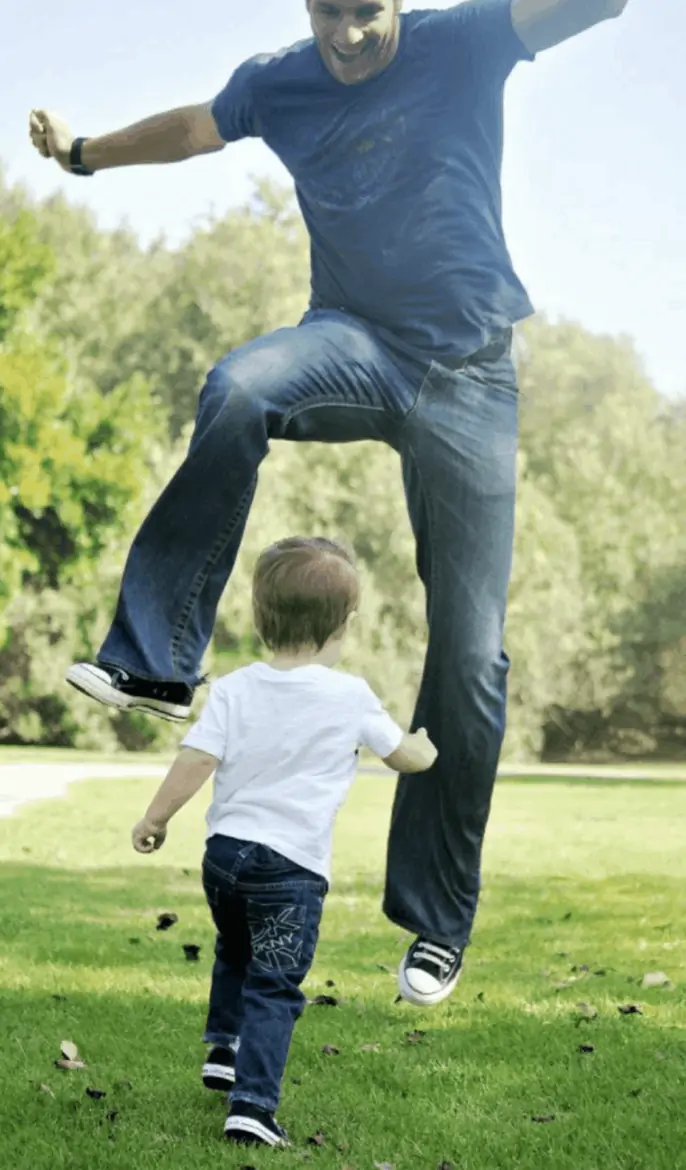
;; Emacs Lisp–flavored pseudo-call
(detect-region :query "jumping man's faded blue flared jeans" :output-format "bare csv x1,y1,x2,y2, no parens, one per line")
98,310,519,947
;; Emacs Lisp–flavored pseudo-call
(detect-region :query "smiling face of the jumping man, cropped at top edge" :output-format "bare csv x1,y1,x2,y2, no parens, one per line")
308,0,402,85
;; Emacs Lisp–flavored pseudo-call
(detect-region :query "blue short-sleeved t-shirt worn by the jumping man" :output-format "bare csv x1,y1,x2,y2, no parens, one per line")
213,0,533,362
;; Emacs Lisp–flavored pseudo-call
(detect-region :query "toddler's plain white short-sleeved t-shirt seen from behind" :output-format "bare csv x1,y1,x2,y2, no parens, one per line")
181,662,403,881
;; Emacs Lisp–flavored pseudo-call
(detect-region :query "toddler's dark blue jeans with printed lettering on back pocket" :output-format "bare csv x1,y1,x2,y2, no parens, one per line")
203,834,328,1113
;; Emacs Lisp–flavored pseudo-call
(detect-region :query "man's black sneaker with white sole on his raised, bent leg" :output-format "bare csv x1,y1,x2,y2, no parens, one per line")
67,662,193,723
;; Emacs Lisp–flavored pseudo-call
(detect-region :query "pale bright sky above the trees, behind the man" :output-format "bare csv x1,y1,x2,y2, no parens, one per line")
0,0,686,394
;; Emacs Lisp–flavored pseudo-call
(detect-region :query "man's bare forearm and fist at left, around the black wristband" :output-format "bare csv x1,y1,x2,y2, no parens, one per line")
29,102,226,171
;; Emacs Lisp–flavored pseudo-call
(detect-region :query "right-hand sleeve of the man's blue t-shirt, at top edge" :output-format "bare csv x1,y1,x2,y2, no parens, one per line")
446,0,535,78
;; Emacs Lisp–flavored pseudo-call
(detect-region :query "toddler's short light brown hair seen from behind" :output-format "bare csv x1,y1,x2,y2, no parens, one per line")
253,536,359,651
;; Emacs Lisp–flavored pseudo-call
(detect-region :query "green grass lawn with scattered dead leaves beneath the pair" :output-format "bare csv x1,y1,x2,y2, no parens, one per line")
0,777,686,1170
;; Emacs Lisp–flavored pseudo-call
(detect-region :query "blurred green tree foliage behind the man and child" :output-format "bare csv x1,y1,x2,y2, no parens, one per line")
0,169,686,758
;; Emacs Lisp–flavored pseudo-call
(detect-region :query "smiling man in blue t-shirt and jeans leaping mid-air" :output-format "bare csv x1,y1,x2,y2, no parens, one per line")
30,0,626,1005
